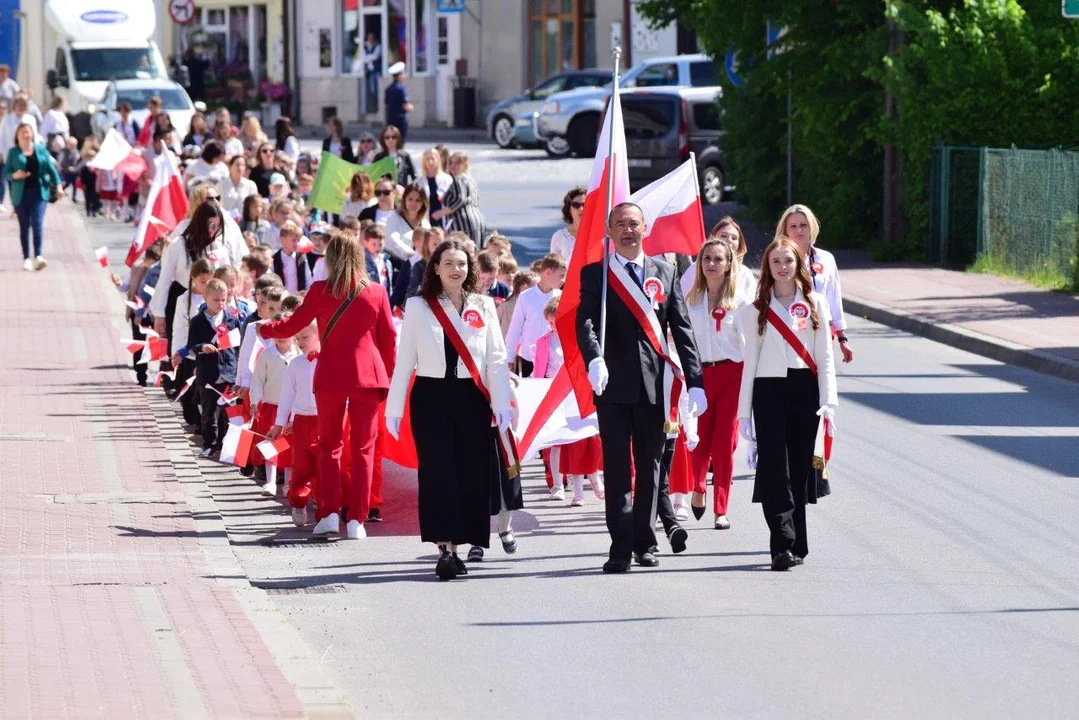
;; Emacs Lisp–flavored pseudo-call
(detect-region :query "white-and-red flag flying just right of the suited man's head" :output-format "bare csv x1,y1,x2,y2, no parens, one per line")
629,159,705,257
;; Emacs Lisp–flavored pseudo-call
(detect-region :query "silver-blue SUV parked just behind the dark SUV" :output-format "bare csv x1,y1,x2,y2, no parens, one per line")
533,55,718,158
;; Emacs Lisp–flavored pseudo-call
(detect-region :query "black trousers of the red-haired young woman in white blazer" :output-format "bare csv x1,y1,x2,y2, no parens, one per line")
753,369,820,557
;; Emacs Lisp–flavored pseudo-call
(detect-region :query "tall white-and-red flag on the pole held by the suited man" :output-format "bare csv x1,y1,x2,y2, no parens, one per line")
518,87,629,458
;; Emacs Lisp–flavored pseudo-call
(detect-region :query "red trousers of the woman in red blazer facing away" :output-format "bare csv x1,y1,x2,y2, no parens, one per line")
315,388,386,522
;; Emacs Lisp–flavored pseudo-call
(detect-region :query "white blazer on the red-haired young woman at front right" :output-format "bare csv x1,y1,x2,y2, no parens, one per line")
737,290,839,420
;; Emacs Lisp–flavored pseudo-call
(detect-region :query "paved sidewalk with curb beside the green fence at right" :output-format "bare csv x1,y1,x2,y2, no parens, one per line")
839,256,1079,380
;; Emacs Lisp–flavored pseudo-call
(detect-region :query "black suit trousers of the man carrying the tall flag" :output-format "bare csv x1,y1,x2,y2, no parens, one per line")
596,394,666,560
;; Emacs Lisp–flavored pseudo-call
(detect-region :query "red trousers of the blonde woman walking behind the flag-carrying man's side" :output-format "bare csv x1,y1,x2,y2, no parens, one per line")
689,363,742,515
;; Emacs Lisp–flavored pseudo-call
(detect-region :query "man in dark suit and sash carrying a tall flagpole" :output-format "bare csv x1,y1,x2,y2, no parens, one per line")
576,202,708,572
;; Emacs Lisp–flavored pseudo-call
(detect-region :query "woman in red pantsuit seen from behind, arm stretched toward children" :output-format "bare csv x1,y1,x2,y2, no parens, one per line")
258,233,397,538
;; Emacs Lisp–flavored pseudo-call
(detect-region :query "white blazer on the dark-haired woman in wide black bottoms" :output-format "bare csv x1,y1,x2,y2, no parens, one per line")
386,294,513,418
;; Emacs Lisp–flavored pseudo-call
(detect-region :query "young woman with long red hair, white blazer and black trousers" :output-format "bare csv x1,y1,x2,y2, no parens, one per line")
738,235,838,570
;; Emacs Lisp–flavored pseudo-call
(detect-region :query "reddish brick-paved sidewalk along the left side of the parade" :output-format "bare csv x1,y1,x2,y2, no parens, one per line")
0,203,346,718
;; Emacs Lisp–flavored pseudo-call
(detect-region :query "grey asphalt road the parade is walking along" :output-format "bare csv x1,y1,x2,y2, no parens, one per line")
86,143,1079,718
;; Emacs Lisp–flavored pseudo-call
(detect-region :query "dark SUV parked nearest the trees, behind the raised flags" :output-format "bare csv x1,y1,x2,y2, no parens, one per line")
619,87,726,205
